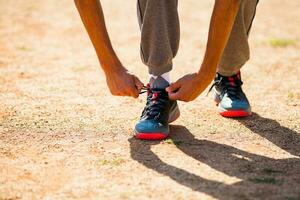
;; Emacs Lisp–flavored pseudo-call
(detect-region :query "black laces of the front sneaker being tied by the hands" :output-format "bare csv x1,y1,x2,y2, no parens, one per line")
140,86,168,119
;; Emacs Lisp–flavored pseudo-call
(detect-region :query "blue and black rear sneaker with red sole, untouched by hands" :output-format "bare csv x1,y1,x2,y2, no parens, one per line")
212,72,251,117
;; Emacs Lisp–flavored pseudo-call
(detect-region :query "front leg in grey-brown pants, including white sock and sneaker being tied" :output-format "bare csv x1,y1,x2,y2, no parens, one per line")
135,0,180,140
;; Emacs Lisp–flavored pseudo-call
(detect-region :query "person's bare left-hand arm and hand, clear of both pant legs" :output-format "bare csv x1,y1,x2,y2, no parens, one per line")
74,0,143,97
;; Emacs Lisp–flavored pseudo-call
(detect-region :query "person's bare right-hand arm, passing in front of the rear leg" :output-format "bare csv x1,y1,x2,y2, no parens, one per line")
167,0,240,101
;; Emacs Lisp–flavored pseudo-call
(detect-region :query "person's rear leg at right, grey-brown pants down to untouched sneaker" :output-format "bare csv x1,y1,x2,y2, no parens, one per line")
215,0,258,117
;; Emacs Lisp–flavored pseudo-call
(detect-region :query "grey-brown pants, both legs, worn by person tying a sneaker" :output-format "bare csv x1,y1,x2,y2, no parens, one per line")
137,0,258,76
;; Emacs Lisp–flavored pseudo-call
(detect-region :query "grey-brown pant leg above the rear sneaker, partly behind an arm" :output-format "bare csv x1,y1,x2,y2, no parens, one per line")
218,0,258,76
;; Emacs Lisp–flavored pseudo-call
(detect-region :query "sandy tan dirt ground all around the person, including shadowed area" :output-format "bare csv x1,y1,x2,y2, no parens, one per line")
0,0,300,200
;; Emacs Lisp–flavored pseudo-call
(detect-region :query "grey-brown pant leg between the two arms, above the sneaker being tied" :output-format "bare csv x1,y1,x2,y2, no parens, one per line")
137,0,180,76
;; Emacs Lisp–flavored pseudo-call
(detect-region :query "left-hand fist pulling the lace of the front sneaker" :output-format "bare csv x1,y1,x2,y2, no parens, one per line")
106,69,144,98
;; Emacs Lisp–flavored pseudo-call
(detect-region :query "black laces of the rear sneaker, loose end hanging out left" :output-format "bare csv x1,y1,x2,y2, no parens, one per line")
207,77,243,99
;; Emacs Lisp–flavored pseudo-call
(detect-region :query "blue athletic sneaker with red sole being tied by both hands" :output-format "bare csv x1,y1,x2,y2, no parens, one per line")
135,77,180,140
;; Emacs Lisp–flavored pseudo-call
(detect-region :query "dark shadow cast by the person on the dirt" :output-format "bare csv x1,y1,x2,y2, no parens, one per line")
129,113,300,200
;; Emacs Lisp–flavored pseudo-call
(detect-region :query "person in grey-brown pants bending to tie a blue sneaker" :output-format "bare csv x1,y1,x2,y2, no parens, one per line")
75,0,258,140
